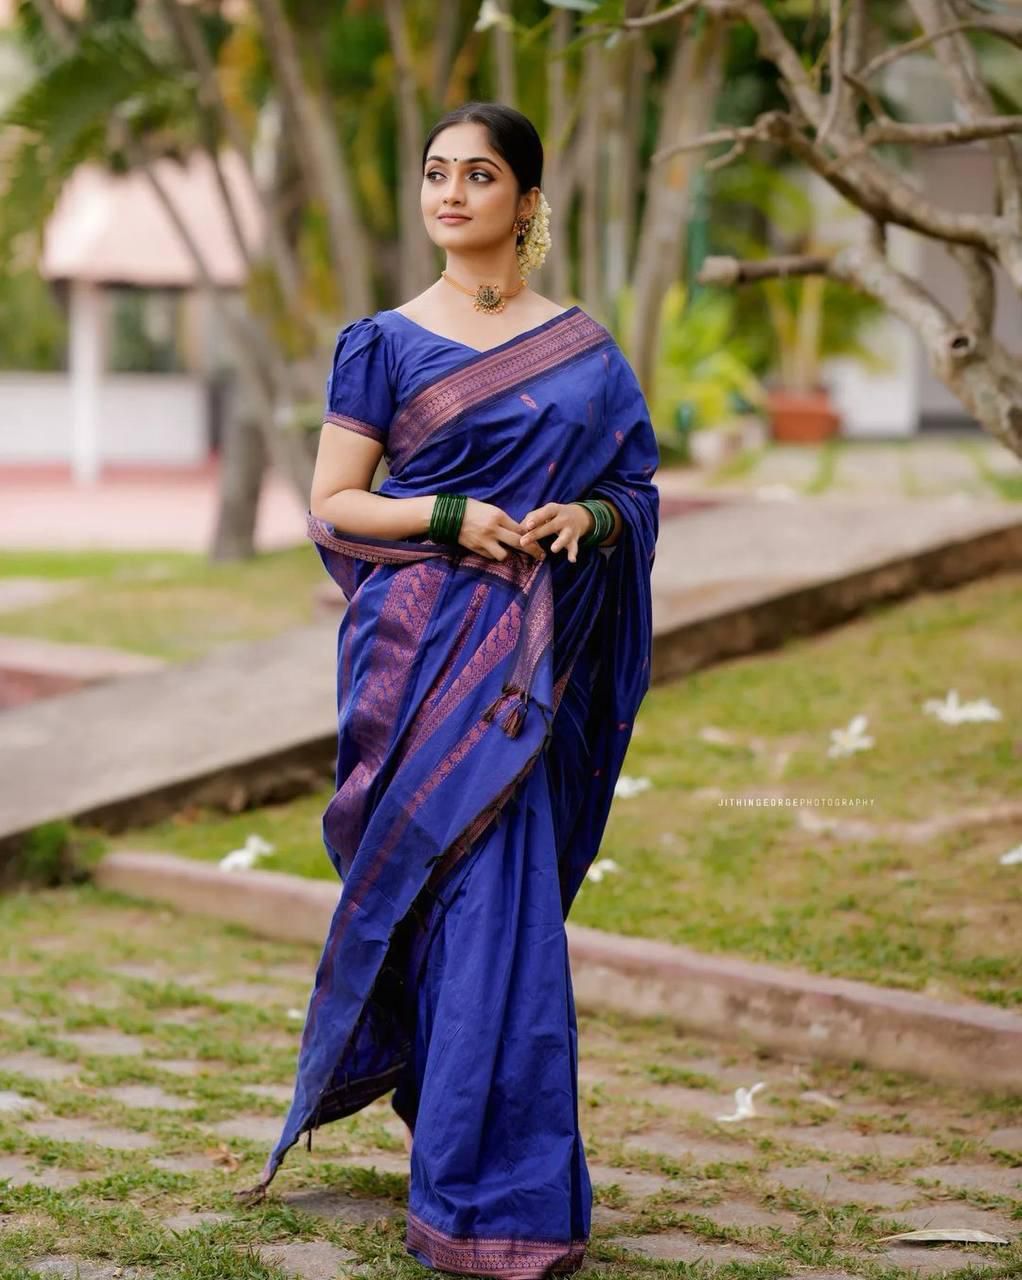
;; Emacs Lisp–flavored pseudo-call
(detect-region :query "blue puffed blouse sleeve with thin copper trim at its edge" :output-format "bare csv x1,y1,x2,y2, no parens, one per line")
323,316,396,444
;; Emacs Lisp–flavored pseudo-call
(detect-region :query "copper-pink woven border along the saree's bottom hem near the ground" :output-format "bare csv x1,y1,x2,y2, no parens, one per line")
405,1208,589,1280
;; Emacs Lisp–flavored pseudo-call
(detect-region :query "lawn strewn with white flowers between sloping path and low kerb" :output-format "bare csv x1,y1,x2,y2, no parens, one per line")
90,575,1022,1006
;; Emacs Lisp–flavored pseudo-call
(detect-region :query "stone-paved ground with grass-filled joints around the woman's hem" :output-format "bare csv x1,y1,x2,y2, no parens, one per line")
0,887,1022,1280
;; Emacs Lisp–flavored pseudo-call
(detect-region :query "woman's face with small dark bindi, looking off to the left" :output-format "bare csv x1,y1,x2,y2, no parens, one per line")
420,120,534,251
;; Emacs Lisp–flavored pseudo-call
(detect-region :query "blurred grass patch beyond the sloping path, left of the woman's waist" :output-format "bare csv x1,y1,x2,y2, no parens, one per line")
0,543,329,662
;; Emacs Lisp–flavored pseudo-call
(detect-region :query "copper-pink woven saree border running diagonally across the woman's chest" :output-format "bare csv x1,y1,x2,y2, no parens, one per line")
388,311,613,476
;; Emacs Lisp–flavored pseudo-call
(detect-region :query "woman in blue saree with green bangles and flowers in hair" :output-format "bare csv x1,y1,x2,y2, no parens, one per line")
241,102,660,1277
